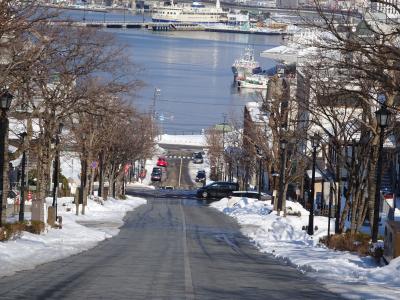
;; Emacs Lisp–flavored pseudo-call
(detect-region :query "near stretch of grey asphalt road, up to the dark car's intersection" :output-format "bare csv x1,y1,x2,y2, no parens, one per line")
0,190,339,299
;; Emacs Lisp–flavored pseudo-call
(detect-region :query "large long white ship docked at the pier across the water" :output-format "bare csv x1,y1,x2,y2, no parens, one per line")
151,0,227,23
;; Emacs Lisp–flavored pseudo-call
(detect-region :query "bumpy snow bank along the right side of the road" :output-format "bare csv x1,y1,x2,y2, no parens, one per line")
211,198,400,299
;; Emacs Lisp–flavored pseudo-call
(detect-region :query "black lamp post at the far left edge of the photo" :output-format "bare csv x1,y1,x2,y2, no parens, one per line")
0,91,14,227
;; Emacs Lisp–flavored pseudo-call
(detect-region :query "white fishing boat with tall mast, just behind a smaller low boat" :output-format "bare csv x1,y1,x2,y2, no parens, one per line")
232,47,262,80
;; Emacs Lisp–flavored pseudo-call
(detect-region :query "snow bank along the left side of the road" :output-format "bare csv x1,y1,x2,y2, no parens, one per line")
0,197,146,277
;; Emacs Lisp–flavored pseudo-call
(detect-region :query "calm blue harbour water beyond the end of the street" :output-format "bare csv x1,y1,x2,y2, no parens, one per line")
60,10,283,134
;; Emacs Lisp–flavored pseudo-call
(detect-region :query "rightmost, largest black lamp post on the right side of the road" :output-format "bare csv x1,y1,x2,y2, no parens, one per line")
372,105,390,243
